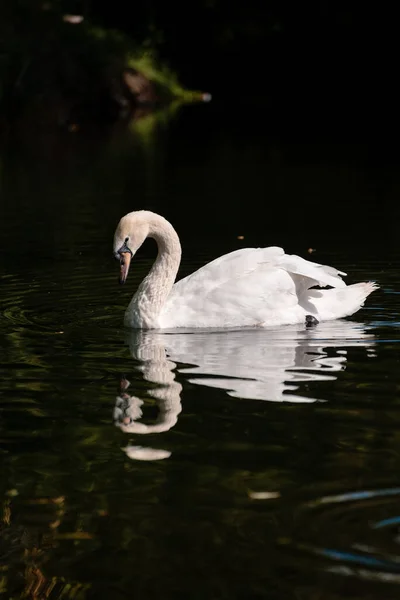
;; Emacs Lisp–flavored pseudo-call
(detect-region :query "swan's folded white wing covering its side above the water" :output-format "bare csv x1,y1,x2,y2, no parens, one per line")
160,246,345,327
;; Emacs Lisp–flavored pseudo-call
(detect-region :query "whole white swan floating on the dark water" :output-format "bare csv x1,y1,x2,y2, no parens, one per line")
114,210,378,329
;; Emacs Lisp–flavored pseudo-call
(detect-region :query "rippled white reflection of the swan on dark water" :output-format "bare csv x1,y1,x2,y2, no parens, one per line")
114,321,374,460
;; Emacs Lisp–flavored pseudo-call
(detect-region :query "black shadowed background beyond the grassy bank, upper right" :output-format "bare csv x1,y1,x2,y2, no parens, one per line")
90,0,398,136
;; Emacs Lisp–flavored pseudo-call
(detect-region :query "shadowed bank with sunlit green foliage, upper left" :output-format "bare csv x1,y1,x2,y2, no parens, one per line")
0,0,190,122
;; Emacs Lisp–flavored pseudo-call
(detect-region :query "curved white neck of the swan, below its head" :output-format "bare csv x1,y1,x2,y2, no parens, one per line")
125,215,182,329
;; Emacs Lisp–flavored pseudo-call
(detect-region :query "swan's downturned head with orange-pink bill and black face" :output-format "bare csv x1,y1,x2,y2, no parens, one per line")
114,210,149,283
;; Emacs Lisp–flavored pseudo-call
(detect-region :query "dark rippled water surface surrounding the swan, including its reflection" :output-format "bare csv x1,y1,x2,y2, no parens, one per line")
0,107,400,600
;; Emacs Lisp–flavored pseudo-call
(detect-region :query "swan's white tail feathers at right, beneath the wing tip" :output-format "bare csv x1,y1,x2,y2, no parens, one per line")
308,281,379,321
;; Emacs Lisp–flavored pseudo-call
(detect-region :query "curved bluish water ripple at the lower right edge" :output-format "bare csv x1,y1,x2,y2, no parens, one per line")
279,487,400,583
